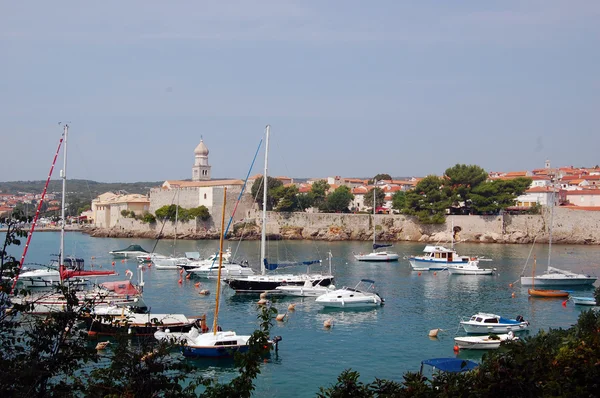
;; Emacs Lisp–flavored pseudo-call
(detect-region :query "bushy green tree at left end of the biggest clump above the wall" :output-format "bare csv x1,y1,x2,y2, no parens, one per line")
404,175,451,224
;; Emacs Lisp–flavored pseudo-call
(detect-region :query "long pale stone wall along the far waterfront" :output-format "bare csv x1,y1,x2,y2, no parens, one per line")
83,207,600,244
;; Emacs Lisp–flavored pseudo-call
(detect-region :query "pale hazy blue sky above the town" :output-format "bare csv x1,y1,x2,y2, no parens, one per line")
0,0,600,182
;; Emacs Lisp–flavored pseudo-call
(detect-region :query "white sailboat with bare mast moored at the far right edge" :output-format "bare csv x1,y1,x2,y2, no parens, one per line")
521,187,598,286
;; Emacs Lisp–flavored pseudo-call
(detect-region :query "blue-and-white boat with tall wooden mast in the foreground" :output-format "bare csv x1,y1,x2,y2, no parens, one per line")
154,188,281,357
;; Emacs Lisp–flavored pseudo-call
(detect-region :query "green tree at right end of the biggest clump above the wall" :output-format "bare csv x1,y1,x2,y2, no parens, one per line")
470,177,531,213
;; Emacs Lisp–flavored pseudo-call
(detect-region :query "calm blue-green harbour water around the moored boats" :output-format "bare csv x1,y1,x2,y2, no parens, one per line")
5,232,600,397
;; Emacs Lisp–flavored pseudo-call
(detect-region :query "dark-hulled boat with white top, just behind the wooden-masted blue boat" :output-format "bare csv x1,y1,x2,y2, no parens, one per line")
81,305,201,336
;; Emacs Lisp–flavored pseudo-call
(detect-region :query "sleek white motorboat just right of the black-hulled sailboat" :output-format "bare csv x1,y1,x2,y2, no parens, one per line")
315,279,384,308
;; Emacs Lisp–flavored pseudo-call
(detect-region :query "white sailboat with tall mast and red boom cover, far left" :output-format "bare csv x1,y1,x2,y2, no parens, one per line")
18,124,116,287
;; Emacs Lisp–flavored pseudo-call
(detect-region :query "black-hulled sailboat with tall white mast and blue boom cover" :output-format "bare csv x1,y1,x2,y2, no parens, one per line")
225,125,333,293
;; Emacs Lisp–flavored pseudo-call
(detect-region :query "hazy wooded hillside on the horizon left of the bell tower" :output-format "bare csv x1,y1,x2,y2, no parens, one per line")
0,179,164,199
